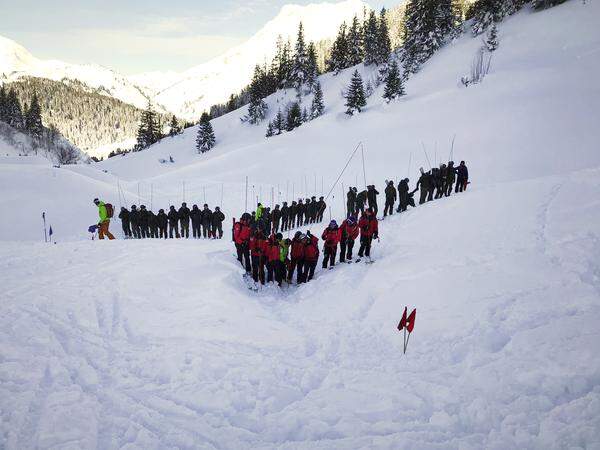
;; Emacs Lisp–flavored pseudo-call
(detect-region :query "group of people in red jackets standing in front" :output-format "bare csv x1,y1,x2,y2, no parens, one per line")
233,208,379,286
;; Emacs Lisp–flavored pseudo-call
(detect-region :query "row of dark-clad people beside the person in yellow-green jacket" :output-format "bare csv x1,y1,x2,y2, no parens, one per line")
119,202,225,239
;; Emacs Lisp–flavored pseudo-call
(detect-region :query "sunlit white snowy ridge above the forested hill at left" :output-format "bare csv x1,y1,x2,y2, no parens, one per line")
0,36,157,109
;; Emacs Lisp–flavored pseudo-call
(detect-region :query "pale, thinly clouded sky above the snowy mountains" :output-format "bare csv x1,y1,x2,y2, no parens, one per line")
0,0,400,74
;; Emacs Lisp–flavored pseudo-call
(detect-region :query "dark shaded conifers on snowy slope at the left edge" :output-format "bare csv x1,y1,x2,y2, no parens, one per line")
0,86,81,164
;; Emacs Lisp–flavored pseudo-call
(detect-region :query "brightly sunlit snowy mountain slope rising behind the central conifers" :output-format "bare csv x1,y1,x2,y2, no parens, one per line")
146,0,369,120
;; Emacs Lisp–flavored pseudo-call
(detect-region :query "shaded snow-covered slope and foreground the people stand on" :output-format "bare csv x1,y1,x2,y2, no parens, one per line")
0,1,600,449
